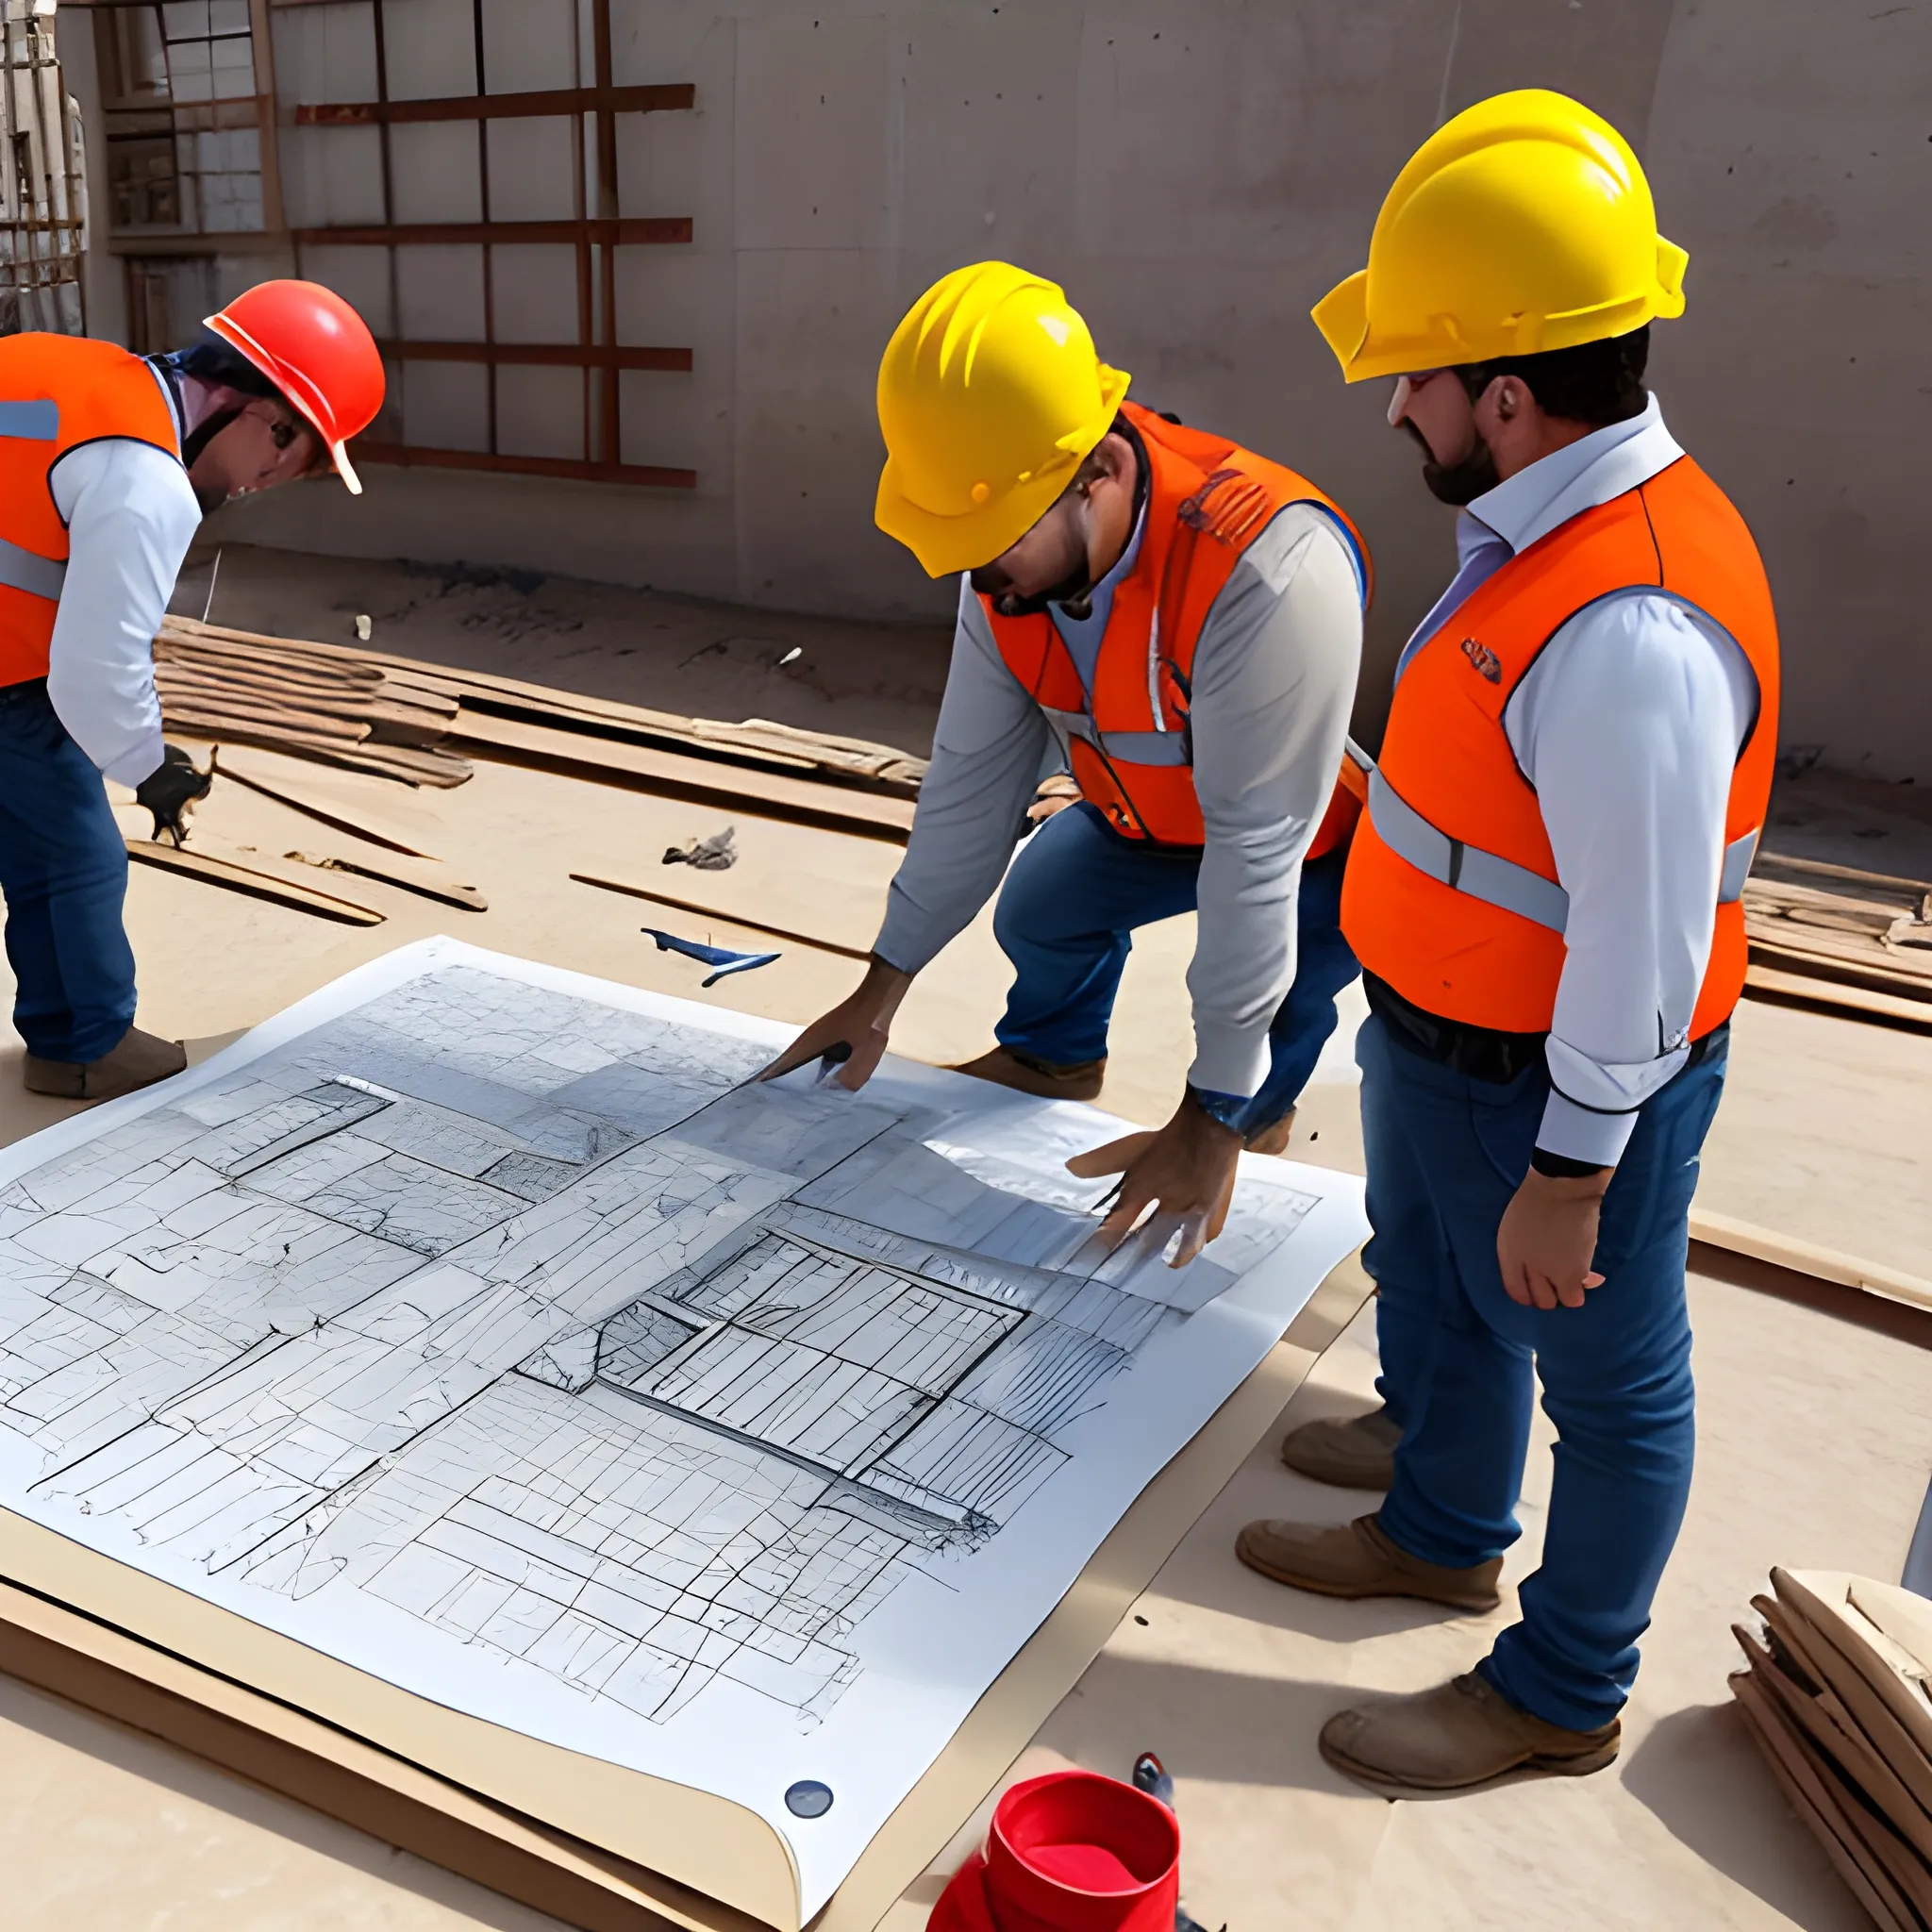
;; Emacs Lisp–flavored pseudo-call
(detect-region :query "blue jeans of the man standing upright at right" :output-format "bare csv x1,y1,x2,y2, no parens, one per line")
1357,1014,1725,1731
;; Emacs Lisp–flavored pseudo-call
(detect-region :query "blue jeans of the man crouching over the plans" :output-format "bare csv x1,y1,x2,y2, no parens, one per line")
993,802,1360,1134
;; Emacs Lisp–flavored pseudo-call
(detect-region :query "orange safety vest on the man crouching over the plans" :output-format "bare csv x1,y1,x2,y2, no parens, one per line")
979,402,1372,858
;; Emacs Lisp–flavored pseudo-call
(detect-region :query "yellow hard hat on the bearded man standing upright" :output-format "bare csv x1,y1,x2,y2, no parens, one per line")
1314,87,1689,383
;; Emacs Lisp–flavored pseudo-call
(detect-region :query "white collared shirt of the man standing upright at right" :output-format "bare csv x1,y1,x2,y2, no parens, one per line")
1397,396,1758,1167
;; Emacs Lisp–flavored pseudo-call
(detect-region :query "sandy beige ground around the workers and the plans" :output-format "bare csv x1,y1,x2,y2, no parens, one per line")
0,553,1932,1932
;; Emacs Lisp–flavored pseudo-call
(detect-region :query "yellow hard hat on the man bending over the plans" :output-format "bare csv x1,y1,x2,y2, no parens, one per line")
874,260,1128,577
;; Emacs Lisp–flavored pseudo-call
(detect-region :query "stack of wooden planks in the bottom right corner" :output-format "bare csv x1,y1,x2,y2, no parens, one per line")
1731,1569,1932,1932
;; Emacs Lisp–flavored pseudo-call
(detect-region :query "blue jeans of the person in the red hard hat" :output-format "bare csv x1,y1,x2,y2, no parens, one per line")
0,680,133,1066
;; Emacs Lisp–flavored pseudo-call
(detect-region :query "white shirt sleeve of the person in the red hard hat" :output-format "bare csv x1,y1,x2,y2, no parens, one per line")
46,358,201,784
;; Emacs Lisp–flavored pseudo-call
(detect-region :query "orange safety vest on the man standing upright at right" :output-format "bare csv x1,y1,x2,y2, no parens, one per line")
1341,456,1777,1040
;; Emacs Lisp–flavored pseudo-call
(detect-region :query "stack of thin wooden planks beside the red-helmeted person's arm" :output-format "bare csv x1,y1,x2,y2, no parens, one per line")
155,616,472,787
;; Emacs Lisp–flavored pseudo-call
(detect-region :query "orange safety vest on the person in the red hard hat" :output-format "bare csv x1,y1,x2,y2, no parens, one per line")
0,334,182,686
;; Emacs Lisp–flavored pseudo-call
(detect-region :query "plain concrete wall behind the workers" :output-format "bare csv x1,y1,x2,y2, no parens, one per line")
166,0,1932,780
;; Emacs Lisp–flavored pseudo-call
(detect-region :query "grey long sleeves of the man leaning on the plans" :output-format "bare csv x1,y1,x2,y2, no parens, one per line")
874,505,1362,1093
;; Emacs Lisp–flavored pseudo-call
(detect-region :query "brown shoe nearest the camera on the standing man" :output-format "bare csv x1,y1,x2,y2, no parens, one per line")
1322,1672,1623,1797
